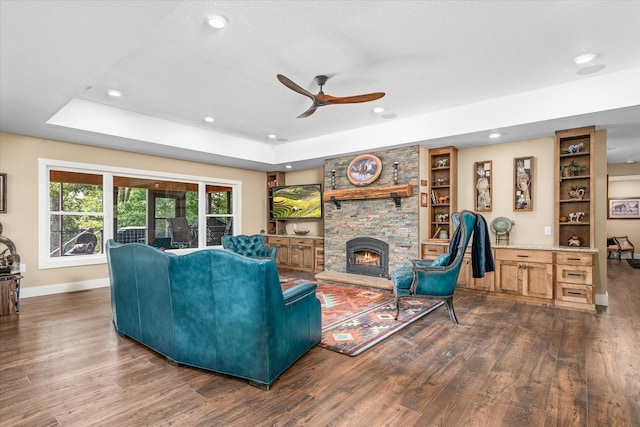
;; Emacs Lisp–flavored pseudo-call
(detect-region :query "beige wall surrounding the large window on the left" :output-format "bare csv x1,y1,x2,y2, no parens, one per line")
0,133,266,293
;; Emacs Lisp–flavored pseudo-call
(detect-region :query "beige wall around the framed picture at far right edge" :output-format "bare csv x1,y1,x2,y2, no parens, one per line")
607,163,640,254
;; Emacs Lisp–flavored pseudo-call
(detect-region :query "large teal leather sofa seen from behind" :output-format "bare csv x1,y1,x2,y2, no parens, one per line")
106,240,322,389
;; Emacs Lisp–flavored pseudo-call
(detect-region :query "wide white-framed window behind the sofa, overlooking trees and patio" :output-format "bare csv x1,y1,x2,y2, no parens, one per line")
40,159,240,268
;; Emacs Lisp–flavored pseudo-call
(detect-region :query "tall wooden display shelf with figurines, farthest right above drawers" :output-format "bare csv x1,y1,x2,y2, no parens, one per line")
555,126,595,247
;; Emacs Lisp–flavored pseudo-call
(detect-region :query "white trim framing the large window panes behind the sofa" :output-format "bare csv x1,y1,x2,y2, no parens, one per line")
38,158,242,269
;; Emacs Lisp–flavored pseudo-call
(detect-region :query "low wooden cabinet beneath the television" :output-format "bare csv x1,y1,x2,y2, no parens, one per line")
267,236,324,272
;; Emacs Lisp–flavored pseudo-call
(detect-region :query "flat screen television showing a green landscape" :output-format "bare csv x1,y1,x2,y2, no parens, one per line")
270,184,322,219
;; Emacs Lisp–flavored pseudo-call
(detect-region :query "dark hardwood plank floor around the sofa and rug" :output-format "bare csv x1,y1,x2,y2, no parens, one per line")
0,260,640,427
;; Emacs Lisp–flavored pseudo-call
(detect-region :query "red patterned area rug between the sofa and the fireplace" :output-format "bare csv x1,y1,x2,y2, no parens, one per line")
282,280,443,356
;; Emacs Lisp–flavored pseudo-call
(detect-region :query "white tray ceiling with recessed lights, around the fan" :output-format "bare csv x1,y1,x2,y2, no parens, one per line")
0,0,640,171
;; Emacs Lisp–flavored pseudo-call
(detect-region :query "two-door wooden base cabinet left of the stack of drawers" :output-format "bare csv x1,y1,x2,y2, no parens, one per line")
495,249,553,300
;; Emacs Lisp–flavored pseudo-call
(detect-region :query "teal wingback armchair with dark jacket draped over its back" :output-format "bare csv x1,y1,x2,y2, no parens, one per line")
392,211,476,323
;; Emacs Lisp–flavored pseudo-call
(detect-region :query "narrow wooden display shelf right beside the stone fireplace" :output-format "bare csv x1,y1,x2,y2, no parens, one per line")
429,147,458,241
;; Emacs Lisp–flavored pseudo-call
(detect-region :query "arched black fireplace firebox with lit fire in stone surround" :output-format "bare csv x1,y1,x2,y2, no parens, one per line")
347,237,389,278
